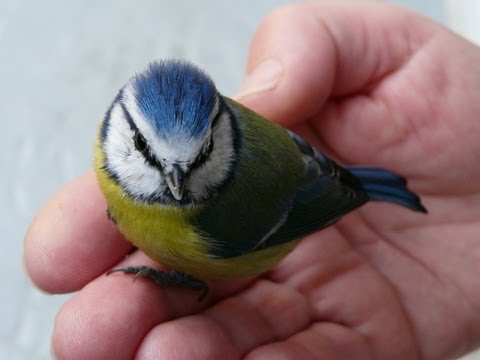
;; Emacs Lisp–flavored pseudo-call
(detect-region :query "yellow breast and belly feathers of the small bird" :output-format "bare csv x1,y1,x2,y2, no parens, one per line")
95,140,297,279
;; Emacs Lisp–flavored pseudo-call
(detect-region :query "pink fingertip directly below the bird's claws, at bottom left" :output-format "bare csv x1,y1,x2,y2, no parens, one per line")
52,253,171,359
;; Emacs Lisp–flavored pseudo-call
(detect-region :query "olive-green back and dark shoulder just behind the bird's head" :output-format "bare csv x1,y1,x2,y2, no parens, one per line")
194,98,305,257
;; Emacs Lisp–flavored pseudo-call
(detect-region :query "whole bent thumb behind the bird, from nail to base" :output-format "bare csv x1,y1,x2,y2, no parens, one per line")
237,3,436,126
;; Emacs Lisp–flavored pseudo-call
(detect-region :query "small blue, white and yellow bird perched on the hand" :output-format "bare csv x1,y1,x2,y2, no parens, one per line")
95,60,426,298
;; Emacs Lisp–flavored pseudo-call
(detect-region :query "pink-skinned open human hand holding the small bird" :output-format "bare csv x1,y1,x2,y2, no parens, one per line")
25,3,480,359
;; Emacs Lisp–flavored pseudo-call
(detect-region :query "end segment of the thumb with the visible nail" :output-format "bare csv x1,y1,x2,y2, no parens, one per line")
236,5,335,127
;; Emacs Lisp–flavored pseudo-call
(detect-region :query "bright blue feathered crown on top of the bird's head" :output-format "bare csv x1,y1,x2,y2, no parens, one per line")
132,60,218,138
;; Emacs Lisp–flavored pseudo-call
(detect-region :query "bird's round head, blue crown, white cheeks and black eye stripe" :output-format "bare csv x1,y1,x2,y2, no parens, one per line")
100,60,235,204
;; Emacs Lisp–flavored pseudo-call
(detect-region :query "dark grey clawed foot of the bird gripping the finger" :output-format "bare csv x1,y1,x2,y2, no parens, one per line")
106,265,208,301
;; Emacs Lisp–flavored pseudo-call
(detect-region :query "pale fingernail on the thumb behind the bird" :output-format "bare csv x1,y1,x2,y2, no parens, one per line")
235,59,283,99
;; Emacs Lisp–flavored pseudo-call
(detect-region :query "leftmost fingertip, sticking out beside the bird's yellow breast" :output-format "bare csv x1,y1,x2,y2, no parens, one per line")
24,172,132,293
